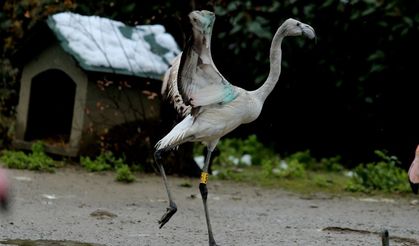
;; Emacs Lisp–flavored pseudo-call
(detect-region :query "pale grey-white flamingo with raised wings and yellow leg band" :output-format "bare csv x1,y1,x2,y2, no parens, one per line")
154,10,315,246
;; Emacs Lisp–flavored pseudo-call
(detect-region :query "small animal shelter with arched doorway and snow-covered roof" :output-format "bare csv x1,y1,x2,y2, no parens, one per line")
13,12,180,156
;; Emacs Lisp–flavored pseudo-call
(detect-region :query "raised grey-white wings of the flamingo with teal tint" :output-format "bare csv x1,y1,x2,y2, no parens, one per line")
162,11,238,116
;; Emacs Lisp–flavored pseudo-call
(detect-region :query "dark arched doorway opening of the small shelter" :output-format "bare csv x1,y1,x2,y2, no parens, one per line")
25,69,76,145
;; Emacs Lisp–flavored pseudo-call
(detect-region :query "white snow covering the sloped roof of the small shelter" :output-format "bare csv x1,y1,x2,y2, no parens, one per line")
47,12,180,79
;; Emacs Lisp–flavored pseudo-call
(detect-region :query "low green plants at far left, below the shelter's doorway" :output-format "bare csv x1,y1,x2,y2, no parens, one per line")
0,141,57,172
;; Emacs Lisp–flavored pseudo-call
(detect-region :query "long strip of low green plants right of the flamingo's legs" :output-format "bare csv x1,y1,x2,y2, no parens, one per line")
199,135,410,193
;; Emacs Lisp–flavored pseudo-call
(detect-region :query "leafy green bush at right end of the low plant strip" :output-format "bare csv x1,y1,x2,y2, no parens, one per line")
347,150,410,192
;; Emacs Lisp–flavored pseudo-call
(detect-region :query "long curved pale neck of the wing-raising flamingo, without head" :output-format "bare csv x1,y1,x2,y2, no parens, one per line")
254,26,284,102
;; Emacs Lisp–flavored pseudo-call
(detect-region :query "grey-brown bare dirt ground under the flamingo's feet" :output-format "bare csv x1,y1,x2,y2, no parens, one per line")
0,167,419,246
